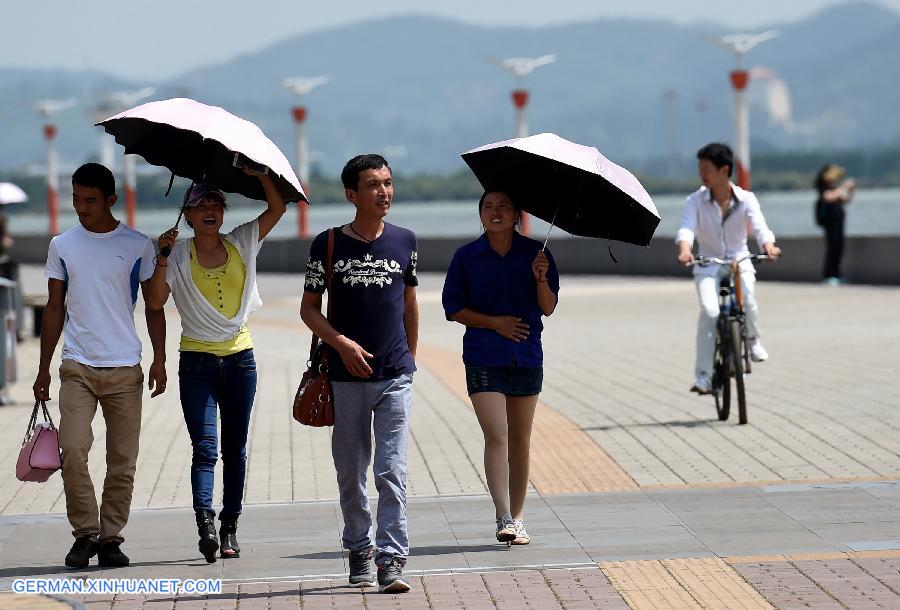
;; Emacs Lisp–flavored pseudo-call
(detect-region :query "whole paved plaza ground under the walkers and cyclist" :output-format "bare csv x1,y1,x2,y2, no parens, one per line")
0,270,900,609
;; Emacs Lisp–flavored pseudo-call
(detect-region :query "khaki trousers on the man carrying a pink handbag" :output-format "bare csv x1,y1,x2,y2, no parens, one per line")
59,360,144,542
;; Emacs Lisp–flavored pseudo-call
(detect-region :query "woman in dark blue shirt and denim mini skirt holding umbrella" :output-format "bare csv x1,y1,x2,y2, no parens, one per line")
443,191,559,544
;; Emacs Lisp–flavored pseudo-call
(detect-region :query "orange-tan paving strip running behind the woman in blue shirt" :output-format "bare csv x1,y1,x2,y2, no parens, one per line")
416,345,638,494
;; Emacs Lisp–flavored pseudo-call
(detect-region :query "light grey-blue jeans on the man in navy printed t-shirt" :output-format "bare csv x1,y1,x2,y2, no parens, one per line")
331,373,413,566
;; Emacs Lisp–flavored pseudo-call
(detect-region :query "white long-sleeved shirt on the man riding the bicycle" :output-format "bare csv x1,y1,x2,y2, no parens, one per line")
675,184,775,275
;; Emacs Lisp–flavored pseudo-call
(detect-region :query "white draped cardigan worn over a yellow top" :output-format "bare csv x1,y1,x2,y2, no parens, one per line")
166,219,262,342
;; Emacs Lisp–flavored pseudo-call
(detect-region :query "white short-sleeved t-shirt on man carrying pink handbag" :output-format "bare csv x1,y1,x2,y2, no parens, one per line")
46,222,155,367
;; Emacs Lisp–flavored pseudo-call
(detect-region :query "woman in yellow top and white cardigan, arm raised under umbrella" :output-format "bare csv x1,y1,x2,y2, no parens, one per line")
148,172,286,563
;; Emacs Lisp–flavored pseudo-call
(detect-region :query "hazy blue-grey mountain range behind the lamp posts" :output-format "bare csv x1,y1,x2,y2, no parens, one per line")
0,2,900,175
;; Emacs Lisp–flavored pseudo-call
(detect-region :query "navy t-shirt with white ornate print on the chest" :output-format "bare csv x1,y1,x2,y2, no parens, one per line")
304,223,419,381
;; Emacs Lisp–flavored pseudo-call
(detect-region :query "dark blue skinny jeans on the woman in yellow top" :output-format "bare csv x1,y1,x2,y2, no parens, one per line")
178,349,256,518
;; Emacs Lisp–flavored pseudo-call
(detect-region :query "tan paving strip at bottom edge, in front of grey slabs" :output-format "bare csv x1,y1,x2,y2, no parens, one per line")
600,557,772,610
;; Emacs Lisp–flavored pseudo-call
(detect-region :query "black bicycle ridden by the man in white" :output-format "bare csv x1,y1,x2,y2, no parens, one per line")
691,254,774,424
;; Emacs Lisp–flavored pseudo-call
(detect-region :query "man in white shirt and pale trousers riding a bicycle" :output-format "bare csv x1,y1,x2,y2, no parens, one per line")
675,143,781,394
